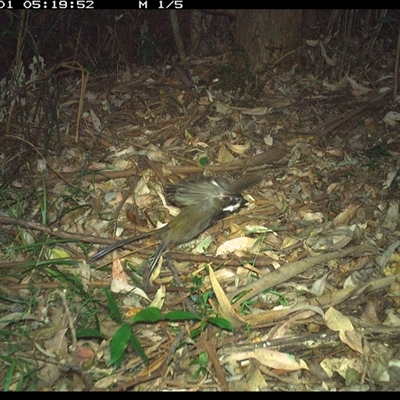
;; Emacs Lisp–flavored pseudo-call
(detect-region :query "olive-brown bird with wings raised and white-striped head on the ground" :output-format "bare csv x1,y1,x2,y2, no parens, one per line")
91,177,261,276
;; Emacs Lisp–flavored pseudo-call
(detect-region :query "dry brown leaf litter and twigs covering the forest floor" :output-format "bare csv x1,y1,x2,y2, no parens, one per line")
0,22,400,390
